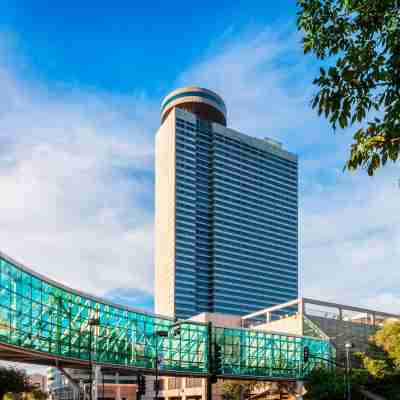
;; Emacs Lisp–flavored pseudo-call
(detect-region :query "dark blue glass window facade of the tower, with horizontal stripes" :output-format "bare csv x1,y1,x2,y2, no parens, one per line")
175,118,298,318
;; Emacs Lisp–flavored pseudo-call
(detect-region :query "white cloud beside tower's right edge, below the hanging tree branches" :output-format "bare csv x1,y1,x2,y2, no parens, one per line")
301,169,400,313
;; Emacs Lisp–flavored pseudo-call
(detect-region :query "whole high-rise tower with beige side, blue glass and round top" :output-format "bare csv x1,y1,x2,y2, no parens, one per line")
155,87,298,318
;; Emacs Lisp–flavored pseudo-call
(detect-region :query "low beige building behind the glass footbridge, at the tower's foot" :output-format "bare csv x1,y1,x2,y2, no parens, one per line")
145,298,400,400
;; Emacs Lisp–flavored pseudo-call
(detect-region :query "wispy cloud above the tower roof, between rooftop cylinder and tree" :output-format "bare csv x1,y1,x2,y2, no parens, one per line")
179,28,324,147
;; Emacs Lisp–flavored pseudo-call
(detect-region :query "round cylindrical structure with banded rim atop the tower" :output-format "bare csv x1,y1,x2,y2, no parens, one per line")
161,86,226,126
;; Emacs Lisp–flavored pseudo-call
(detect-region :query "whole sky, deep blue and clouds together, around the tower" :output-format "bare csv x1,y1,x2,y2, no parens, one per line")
0,0,400,318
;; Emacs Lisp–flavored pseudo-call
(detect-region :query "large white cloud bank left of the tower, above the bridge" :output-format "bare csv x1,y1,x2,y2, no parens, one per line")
0,36,157,295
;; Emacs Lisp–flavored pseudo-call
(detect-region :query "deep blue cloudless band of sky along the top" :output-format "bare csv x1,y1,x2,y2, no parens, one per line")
0,0,295,96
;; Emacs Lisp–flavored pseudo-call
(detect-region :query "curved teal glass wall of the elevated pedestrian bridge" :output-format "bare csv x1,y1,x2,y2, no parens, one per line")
0,253,331,379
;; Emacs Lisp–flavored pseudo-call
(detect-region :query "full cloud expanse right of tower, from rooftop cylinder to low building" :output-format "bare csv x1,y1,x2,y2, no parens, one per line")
179,28,400,314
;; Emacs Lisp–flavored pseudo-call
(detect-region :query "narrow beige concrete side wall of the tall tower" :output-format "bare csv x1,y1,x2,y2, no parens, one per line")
154,110,176,317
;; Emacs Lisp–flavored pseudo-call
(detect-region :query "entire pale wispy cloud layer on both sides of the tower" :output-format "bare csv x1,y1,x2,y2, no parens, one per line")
0,20,400,324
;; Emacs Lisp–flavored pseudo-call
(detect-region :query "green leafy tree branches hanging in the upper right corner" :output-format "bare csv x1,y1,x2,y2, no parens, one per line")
297,0,400,175
